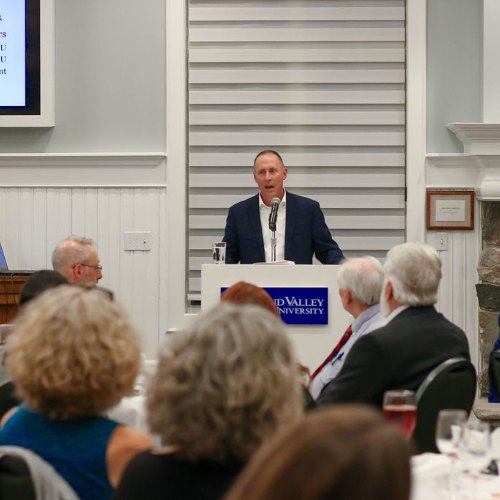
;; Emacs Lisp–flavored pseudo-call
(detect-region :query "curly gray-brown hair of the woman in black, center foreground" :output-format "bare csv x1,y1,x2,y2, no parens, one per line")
147,303,302,461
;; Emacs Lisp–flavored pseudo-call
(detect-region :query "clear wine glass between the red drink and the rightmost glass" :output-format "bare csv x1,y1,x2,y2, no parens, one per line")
436,410,467,500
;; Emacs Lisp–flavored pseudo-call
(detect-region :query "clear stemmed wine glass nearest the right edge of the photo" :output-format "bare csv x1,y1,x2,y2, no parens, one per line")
459,422,491,498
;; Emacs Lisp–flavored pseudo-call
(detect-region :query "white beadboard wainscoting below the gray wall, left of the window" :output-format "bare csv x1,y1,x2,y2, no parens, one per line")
0,155,168,355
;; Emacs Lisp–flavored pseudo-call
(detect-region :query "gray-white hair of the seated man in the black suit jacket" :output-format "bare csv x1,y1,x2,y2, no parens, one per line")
384,243,441,306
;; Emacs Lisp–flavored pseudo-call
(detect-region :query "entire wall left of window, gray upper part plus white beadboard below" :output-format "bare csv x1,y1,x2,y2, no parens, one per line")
0,0,167,355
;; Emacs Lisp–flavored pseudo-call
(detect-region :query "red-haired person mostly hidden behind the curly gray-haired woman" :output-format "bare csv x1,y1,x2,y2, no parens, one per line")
220,281,318,410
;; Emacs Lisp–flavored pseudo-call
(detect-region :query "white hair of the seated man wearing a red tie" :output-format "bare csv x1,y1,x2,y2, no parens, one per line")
337,255,384,306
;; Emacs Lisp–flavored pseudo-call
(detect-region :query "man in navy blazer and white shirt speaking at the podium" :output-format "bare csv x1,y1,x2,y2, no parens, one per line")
223,150,344,264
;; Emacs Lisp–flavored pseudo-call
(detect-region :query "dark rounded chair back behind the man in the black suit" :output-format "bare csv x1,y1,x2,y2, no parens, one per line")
413,358,476,453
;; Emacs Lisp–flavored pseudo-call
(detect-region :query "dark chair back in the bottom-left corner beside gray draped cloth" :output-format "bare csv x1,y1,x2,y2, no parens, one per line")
0,455,36,500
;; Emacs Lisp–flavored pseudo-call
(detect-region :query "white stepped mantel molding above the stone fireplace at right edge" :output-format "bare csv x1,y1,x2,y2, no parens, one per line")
447,123,500,154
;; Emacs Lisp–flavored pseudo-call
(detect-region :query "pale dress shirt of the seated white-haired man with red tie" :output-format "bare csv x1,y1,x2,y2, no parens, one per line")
309,304,388,399
